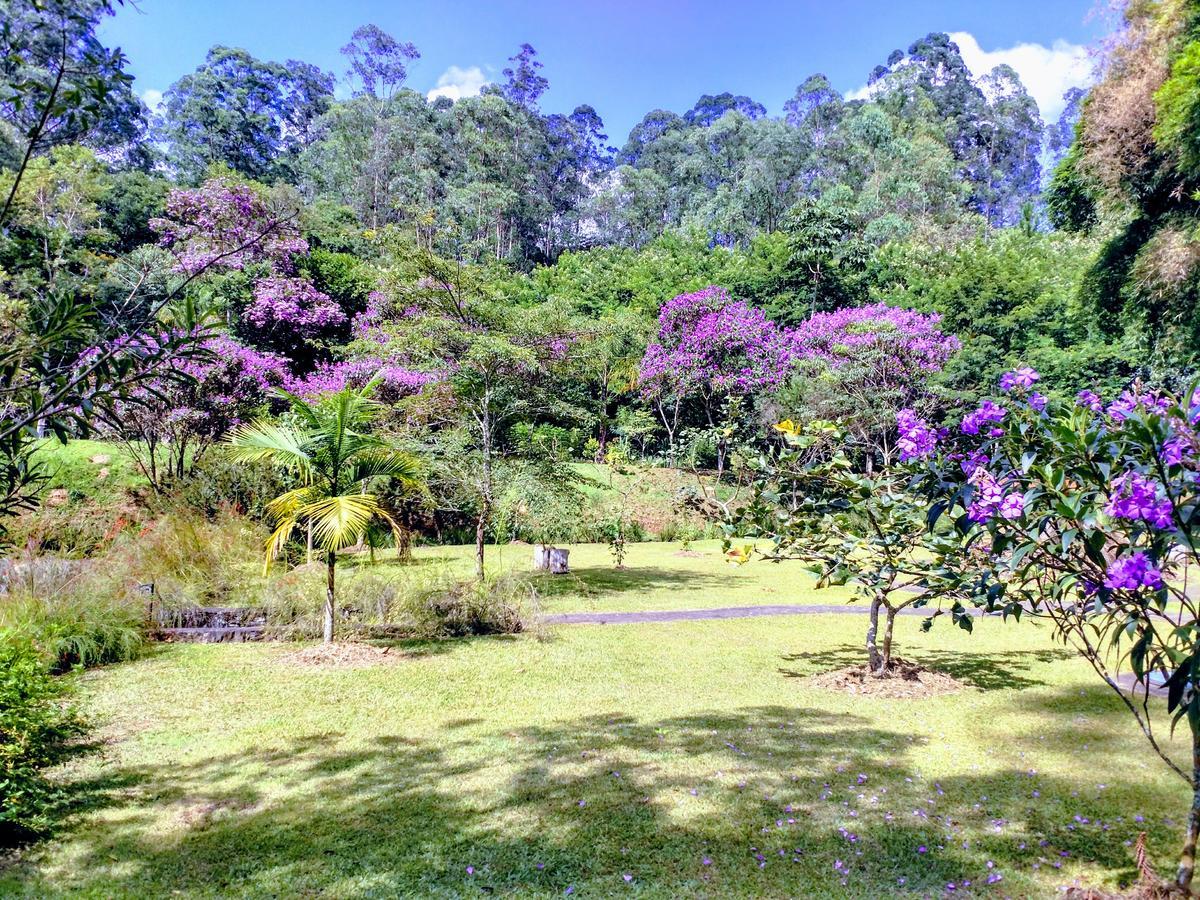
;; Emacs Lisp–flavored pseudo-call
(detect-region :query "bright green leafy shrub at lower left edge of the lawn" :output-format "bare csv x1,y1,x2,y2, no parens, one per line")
0,630,84,847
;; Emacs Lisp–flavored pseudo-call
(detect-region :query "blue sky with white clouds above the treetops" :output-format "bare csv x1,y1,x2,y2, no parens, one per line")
103,0,1103,145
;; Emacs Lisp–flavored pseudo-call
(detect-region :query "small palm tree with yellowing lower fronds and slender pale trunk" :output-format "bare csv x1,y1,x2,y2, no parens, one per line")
228,382,422,643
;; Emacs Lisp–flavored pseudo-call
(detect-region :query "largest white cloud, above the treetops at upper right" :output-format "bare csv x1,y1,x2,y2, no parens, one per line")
950,31,1092,122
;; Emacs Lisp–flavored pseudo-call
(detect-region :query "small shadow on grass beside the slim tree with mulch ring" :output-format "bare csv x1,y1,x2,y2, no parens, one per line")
779,644,1075,691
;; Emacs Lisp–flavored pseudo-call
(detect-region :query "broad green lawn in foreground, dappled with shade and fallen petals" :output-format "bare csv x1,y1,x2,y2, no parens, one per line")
0,556,1188,898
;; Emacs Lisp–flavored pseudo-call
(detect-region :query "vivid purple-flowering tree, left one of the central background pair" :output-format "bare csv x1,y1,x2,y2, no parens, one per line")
638,286,793,470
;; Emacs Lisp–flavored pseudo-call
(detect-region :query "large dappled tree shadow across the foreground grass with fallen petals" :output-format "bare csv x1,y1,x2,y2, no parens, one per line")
7,706,1186,896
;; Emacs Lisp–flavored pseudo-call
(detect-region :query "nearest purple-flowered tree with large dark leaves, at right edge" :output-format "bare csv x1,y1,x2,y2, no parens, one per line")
902,368,1200,889
